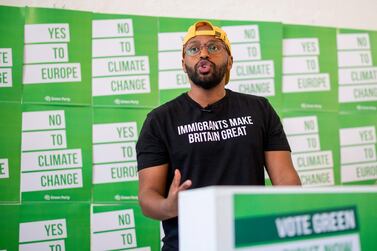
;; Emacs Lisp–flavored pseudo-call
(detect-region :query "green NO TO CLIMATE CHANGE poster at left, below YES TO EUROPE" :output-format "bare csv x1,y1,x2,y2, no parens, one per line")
21,105,92,201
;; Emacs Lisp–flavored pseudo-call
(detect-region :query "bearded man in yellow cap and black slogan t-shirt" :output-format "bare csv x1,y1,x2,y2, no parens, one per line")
136,21,300,250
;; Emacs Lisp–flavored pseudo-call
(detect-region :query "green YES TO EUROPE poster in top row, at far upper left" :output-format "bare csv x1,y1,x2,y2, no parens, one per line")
23,8,92,105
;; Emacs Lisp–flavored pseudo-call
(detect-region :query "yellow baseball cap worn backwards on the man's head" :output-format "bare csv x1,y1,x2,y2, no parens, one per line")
182,21,232,84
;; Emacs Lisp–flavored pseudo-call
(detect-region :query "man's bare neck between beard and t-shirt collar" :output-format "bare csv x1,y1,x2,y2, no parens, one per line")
188,84,226,108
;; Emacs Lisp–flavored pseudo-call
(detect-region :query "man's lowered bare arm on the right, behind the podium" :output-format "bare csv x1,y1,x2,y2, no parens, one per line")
264,151,301,185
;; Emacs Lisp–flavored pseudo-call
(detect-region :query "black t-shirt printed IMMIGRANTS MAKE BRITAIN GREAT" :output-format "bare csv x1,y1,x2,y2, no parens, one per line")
136,90,290,250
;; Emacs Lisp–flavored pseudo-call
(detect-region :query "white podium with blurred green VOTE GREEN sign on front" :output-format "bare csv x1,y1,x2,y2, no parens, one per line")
179,186,377,251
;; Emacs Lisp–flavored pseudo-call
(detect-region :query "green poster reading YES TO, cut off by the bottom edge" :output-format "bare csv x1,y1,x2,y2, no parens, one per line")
18,202,90,251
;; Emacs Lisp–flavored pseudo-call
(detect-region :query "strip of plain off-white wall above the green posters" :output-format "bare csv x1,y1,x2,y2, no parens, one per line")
0,0,377,30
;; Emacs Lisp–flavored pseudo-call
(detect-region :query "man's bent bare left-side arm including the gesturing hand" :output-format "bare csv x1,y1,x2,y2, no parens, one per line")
139,164,191,220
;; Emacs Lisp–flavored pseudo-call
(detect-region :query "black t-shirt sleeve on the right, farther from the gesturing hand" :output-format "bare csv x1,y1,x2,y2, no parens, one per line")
264,100,291,151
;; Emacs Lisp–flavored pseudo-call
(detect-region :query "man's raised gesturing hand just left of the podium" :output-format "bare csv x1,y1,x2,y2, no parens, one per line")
163,169,192,218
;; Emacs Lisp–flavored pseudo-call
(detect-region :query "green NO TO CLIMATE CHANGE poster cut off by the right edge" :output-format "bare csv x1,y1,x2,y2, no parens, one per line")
337,29,377,111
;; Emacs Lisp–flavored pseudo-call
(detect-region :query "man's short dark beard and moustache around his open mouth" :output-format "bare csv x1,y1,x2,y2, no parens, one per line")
185,60,227,90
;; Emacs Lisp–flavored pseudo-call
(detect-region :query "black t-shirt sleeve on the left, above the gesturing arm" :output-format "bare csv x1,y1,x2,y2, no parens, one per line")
136,114,169,171
